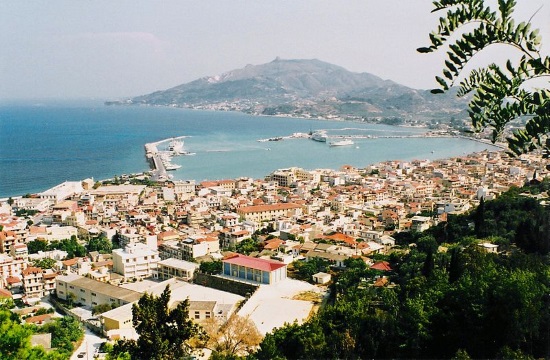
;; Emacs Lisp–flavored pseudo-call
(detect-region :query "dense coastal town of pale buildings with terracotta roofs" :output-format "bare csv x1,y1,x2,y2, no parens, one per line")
0,151,548,356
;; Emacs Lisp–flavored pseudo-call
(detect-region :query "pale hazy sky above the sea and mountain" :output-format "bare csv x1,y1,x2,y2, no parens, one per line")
0,0,550,99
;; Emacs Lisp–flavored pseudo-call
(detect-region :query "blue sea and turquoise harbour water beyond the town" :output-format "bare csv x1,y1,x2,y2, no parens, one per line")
0,100,497,198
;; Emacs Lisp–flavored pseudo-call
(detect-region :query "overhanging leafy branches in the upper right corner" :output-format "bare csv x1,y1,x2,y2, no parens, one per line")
418,0,550,157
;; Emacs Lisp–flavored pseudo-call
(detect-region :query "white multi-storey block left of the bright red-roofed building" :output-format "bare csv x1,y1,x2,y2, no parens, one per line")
113,243,160,279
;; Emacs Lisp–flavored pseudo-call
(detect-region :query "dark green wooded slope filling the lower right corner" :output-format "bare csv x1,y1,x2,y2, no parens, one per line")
254,184,550,359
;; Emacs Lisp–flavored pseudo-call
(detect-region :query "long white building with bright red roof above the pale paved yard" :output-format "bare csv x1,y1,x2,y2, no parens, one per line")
222,254,287,285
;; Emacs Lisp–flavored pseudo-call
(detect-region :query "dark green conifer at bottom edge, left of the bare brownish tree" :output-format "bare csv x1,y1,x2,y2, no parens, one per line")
112,286,203,360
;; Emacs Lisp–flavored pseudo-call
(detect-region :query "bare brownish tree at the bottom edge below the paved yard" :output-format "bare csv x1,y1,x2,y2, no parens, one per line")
203,314,262,358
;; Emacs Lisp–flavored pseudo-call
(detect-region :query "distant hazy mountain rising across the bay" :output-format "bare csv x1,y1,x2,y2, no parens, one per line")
107,58,472,122
